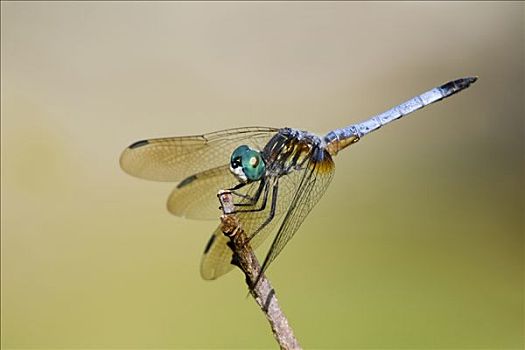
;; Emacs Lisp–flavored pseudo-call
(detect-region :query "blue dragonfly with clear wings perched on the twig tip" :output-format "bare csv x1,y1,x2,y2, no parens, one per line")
120,77,477,280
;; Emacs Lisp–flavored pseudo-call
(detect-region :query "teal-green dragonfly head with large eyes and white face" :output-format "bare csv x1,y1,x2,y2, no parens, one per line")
230,145,266,182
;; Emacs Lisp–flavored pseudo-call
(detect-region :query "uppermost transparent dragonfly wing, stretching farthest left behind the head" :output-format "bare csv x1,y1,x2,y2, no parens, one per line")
120,127,278,181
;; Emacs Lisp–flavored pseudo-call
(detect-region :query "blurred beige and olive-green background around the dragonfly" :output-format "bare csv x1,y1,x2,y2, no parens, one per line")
1,2,525,349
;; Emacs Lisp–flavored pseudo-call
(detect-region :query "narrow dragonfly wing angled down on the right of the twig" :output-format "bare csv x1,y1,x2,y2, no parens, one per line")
261,153,335,273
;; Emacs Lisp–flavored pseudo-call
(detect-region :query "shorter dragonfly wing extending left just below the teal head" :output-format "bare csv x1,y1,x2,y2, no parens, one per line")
167,165,239,220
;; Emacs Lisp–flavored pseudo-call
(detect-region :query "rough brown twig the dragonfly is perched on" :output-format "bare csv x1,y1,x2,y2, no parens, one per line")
217,191,301,349
